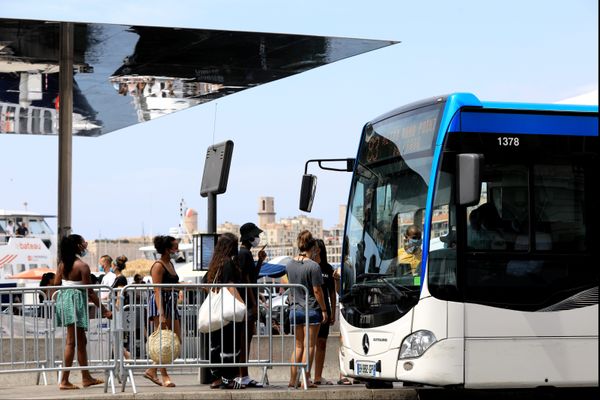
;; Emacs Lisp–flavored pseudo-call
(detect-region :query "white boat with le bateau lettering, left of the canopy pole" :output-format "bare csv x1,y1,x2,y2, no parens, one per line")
0,209,57,286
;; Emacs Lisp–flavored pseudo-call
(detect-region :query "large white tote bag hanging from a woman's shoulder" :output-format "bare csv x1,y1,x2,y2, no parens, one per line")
198,288,246,333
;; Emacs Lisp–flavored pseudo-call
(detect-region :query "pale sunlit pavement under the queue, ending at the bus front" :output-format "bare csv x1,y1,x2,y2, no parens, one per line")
0,374,417,400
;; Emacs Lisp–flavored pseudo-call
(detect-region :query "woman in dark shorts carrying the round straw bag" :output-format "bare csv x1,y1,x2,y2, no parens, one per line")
144,236,181,387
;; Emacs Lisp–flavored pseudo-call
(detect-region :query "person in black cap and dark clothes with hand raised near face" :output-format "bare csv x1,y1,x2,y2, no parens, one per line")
238,222,267,387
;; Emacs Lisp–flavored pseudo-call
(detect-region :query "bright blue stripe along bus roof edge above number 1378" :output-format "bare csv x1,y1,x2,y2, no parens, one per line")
451,111,598,136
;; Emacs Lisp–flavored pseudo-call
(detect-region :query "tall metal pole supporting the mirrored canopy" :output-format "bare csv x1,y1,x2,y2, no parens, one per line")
57,22,74,240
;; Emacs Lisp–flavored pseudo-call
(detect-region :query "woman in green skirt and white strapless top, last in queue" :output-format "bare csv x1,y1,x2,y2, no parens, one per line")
54,234,112,390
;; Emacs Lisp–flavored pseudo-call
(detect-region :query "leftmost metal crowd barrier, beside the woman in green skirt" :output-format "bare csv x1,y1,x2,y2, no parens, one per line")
0,285,117,394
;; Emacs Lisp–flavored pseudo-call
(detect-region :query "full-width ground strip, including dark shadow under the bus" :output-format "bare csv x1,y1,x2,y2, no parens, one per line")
0,374,600,400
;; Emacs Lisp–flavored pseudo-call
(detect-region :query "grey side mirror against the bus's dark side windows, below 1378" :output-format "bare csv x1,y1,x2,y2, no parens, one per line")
456,154,483,206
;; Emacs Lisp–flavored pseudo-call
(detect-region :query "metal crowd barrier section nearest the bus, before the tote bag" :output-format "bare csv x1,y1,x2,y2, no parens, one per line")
117,283,309,393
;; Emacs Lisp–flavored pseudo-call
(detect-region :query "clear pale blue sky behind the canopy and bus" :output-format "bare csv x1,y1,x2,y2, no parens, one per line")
0,0,598,239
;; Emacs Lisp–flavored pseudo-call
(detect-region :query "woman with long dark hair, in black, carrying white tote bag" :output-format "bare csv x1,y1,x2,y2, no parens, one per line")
206,233,245,389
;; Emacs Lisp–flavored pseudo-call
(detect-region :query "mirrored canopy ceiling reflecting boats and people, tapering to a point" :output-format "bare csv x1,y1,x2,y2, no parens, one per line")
0,18,397,136
